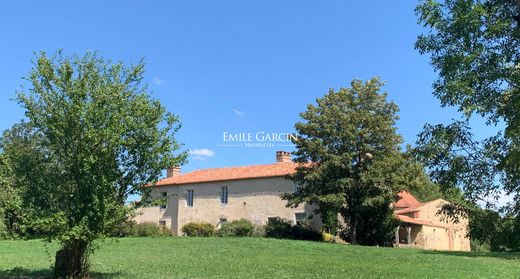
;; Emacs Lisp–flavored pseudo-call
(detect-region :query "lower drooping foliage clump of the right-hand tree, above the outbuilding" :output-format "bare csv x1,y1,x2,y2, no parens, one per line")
414,121,502,206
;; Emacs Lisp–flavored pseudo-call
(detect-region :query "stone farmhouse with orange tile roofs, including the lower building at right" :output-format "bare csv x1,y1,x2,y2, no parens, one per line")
135,151,469,253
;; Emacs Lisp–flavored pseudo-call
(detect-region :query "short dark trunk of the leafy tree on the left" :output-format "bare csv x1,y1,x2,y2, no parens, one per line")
54,241,87,278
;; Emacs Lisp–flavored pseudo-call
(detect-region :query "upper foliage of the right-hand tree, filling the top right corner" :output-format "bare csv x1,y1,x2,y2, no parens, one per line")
415,0,520,122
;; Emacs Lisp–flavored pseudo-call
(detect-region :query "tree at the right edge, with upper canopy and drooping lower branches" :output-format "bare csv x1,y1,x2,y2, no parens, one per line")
415,0,520,212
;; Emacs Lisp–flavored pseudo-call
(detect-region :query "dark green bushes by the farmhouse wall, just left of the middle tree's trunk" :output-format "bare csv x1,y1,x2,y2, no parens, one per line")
265,218,322,241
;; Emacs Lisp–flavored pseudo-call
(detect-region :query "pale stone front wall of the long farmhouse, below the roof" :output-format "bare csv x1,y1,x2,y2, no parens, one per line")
135,177,321,235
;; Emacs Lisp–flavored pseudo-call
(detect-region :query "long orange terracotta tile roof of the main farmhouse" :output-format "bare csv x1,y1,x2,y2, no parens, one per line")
155,162,298,186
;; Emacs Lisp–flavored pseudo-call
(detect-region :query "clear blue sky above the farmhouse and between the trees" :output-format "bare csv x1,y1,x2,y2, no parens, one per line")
0,0,496,174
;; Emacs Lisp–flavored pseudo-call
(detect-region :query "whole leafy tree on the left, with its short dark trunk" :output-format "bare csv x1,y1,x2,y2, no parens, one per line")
2,52,186,277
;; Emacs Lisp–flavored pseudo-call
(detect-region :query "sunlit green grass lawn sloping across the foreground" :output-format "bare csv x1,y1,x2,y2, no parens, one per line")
0,237,520,278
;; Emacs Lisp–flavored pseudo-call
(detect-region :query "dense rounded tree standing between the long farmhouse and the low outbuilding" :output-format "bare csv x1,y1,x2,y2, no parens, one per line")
283,78,427,245
